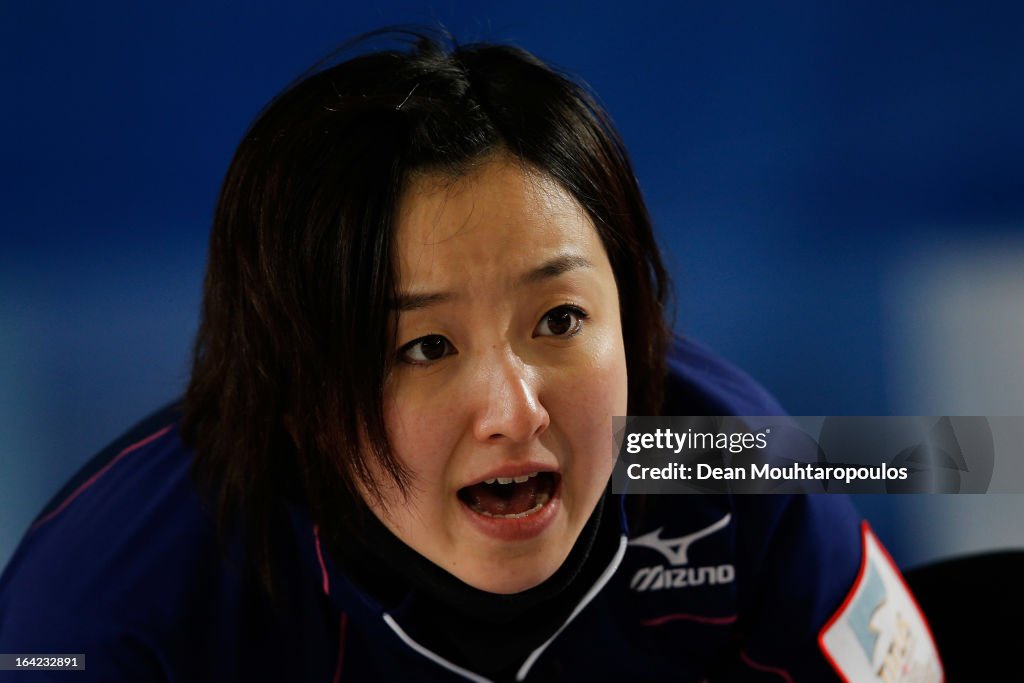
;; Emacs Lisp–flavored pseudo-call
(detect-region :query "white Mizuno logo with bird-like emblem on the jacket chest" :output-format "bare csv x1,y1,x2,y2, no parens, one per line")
629,514,736,592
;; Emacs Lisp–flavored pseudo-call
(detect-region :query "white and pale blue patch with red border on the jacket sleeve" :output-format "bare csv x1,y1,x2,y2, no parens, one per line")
818,522,944,683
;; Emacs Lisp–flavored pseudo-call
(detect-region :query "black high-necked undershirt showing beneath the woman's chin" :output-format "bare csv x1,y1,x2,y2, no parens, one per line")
341,492,621,681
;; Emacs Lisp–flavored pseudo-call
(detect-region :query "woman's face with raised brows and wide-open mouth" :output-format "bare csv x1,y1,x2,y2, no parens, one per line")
370,156,627,593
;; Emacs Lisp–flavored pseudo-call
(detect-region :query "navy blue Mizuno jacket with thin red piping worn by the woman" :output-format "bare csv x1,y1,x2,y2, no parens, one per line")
0,342,937,683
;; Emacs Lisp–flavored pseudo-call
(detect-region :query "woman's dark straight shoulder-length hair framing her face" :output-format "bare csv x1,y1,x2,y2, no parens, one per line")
182,33,669,586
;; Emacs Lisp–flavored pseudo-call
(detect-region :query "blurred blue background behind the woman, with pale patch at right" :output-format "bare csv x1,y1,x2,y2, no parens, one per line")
0,1,1024,564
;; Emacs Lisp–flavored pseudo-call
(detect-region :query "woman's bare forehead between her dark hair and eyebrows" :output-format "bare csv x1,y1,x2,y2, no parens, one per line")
395,156,606,290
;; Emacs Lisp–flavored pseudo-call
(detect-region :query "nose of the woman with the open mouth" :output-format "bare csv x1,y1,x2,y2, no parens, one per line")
473,350,551,443
